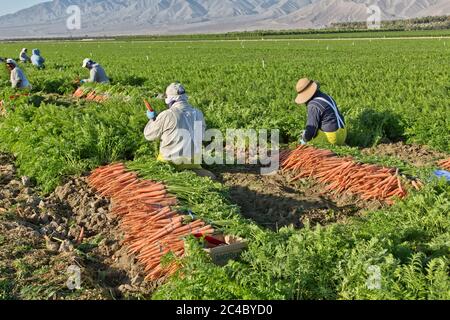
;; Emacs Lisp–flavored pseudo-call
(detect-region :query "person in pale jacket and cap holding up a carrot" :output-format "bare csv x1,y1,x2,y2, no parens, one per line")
144,83,215,179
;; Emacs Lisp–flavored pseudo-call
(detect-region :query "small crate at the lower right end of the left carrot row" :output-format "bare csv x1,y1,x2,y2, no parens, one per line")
205,234,248,266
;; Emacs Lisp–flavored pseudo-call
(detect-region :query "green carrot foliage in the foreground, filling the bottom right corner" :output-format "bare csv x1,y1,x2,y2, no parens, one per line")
154,183,450,300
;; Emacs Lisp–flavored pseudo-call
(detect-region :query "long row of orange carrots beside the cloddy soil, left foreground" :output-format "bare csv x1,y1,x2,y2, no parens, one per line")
89,163,214,281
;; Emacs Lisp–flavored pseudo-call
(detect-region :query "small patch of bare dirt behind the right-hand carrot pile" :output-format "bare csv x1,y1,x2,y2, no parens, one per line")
362,142,448,167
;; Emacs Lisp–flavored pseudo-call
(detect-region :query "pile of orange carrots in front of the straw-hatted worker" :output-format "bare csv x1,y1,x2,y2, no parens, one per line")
280,146,422,204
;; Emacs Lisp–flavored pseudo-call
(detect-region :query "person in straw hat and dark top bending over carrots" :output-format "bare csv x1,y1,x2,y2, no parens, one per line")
295,78,347,145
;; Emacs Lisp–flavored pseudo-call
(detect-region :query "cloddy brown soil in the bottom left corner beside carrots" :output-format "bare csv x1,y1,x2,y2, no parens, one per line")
0,154,155,299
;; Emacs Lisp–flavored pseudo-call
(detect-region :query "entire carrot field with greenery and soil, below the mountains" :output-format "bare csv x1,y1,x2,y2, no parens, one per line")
0,37,450,300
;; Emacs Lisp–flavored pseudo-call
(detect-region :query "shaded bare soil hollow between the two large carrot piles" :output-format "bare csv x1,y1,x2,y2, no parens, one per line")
214,166,374,230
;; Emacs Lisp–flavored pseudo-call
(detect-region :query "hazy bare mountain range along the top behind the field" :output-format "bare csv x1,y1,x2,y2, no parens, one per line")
0,0,450,39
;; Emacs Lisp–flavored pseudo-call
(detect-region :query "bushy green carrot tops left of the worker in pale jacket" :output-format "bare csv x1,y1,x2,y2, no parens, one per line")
0,97,148,192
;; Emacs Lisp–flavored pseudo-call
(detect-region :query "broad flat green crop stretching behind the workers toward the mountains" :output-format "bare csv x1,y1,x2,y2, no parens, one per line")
0,39,450,152
